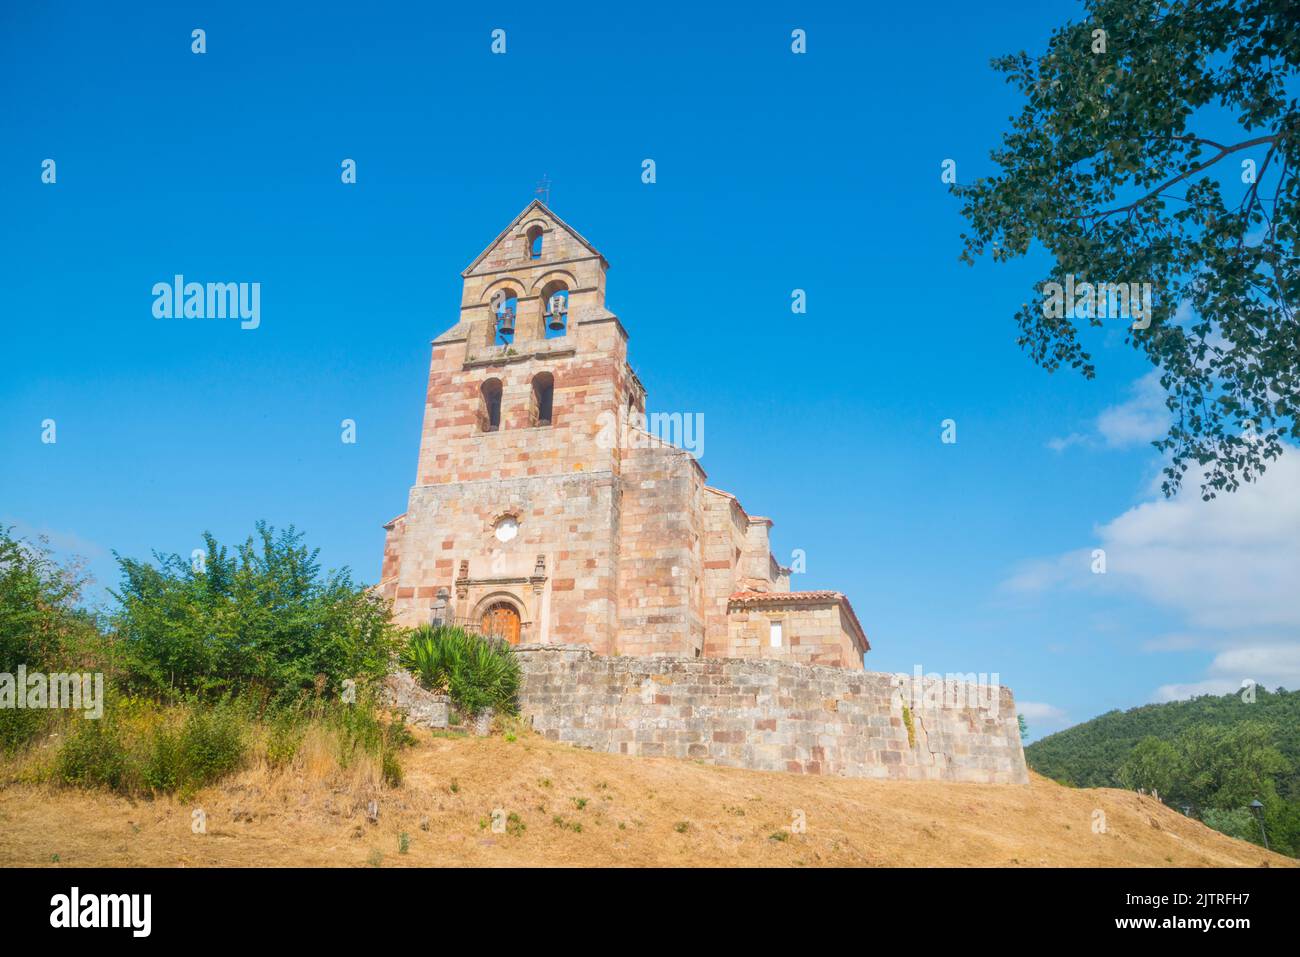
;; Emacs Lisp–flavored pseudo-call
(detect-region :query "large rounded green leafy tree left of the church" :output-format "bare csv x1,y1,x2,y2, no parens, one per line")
114,521,397,698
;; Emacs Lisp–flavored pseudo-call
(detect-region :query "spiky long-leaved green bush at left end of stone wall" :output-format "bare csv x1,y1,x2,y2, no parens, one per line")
403,625,521,716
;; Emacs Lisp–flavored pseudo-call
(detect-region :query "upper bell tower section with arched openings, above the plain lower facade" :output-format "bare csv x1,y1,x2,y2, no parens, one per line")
416,200,645,485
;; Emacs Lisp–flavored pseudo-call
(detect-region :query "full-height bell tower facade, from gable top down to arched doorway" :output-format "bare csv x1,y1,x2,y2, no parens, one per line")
380,200,645,653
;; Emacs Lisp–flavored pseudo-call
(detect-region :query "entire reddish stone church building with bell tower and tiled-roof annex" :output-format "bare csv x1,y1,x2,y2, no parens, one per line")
378,200,870,670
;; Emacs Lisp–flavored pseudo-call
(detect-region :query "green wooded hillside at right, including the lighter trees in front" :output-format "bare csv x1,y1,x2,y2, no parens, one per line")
1024,688,1300,856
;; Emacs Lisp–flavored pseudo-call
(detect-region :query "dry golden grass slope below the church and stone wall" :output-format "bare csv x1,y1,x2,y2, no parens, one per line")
0,732,1296,867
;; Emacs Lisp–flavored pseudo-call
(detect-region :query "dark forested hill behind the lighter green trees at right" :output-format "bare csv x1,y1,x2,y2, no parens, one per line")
1024,688,1300,794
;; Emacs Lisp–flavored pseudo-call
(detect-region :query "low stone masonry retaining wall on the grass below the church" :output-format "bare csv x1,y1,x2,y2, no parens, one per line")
517,645,1028,784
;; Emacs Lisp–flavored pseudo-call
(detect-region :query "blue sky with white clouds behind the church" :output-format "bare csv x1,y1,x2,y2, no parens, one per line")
0,1,1300,735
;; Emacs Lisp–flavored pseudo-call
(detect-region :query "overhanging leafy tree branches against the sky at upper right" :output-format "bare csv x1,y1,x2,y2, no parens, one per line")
953,0,1300,498
